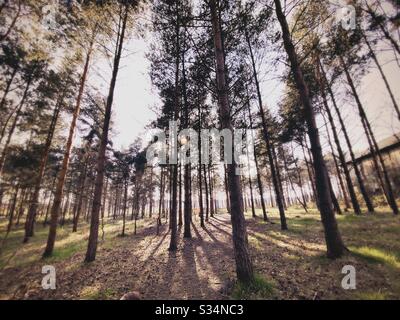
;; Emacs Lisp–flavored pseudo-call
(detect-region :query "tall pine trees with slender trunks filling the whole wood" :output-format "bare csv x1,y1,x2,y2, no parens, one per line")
0,0,400,282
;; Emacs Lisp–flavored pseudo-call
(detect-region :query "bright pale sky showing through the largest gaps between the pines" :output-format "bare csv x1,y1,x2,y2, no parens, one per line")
96,3,400,159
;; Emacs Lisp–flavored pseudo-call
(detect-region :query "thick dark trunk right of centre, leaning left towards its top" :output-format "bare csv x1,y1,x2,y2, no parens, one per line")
274,0,345,259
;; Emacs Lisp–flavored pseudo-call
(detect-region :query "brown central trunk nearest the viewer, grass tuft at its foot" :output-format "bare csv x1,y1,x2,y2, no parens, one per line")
209,0,254,283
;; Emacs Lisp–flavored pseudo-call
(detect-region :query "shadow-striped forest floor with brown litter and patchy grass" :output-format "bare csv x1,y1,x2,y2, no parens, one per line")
0,209,400,299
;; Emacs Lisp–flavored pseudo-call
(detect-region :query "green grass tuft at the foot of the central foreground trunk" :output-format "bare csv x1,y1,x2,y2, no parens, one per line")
231,275,275,300
